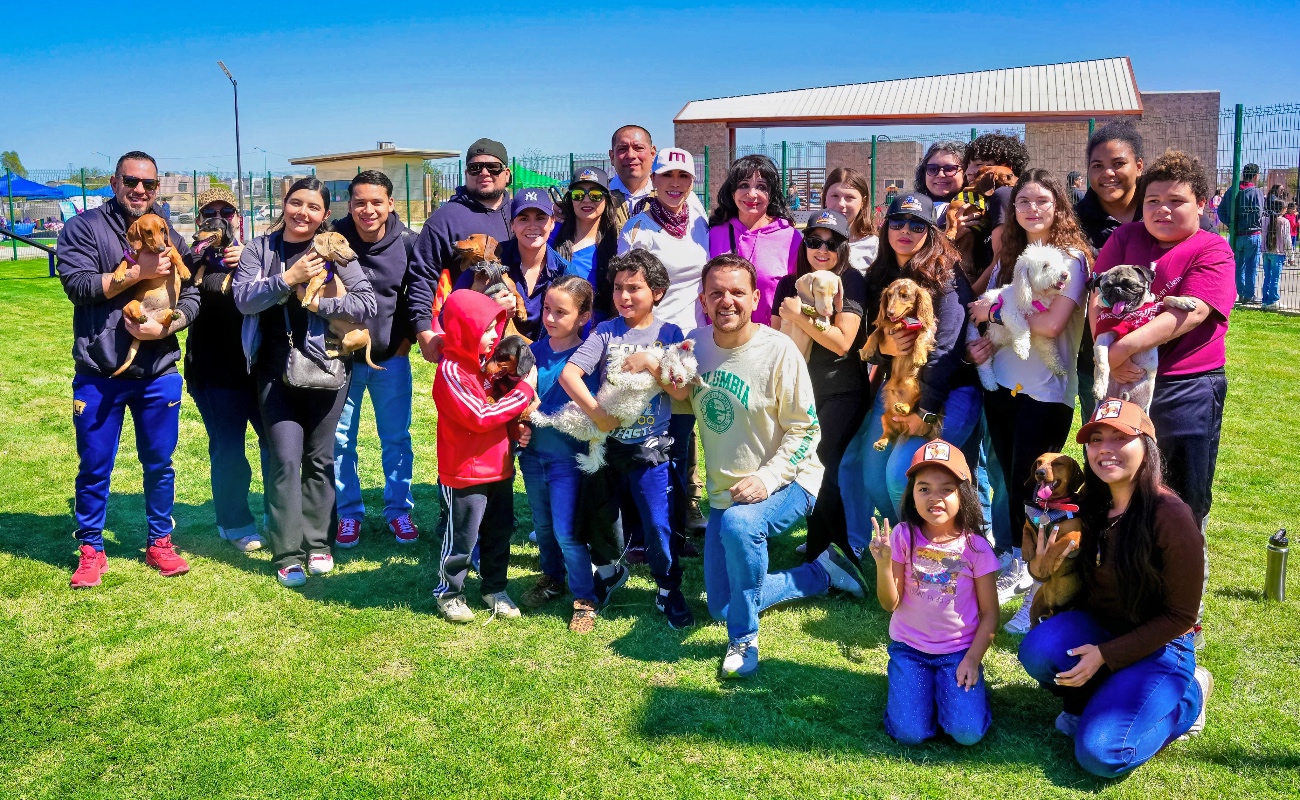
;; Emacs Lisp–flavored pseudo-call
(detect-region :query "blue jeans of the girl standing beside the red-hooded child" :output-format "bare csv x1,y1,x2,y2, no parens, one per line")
519,447,595,602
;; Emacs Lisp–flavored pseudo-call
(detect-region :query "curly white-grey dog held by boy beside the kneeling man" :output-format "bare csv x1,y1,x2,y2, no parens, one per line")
529,340,699,475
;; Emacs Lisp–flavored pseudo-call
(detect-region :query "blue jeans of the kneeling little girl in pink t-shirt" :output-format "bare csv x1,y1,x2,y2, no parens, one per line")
885,641,993,747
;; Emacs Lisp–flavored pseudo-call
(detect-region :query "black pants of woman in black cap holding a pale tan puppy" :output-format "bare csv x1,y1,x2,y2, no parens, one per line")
805,388,871,562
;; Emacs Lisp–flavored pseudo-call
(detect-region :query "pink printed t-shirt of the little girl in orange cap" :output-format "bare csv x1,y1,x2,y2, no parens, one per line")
889,522,998,656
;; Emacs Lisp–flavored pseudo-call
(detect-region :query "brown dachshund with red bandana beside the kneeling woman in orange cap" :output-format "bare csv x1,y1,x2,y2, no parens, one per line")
1022,453,1083,627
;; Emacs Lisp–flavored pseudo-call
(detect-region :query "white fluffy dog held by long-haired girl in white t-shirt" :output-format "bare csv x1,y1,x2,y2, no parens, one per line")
966,245,1070,392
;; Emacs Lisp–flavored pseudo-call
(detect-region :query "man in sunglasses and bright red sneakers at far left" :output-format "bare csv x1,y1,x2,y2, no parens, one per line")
59,151,199,588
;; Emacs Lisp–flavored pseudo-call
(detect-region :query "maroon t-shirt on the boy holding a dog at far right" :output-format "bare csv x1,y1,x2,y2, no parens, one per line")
1092,221,1236,375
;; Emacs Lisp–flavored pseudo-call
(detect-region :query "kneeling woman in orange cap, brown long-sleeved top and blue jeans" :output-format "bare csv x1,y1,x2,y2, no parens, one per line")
1021,399,1214,778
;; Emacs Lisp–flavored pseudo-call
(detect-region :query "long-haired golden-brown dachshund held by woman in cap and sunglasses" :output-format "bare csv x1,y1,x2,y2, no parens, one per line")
859,278,937,450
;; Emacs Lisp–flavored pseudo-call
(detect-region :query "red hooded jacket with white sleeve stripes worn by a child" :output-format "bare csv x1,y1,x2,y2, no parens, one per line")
433,289,534,489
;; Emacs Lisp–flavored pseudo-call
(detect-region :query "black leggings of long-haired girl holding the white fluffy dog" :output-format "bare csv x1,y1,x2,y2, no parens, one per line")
984,386,1082,546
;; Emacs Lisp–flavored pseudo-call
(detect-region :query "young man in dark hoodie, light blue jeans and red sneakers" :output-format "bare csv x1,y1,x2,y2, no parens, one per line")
334,170,420,548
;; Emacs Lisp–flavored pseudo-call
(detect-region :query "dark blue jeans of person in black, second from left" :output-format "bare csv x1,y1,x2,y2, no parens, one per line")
189,381,269,540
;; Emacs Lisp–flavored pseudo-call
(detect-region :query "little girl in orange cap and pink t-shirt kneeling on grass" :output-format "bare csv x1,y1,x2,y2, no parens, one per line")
871,440,998,745
